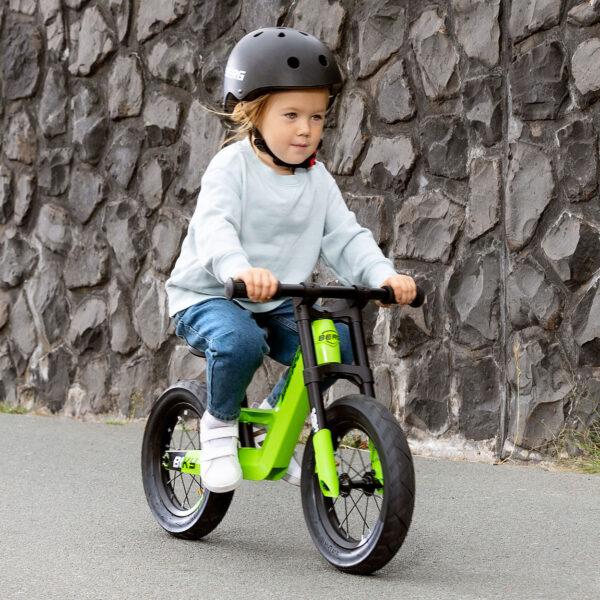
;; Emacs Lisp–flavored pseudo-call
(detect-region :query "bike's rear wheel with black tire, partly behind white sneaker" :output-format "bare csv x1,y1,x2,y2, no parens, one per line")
142,380,233,540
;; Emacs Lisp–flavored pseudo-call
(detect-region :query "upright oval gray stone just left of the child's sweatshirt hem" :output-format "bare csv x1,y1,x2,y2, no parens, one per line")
133,271,169,350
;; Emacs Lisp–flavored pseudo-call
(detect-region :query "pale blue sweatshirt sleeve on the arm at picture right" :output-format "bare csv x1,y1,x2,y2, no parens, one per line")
321,180,396,287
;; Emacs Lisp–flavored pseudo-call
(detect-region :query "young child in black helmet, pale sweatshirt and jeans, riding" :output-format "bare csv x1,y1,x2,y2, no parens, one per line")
166,27,416,493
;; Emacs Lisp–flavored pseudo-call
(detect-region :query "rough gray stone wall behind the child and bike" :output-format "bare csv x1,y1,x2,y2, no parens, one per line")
0,0,600,456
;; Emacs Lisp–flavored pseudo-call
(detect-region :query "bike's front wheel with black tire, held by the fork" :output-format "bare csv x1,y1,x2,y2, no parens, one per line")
301,394,415,575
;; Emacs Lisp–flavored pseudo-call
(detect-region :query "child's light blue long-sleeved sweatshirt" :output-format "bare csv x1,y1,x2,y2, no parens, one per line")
166,138,396,317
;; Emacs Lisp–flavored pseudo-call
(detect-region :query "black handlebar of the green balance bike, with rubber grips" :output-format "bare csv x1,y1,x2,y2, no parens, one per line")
225,278,425,308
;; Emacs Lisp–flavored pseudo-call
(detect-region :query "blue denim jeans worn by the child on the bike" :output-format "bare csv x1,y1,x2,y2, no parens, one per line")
173,298,353,421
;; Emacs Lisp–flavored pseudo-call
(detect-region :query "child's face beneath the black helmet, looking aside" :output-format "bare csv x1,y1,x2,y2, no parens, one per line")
253,88,329,170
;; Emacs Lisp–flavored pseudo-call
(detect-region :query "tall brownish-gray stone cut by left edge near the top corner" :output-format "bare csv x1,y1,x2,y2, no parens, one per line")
0,22,42,100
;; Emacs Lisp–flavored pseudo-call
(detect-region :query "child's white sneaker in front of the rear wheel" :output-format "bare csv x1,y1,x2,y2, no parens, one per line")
200,411,243,494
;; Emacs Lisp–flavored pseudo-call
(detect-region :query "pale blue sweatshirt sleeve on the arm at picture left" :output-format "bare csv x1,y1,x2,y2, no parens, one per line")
190,167,251,284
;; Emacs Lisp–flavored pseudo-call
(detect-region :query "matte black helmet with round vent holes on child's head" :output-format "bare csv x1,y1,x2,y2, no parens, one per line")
223,27,343,112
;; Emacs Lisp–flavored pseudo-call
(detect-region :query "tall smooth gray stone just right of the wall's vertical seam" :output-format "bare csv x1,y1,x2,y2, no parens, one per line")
505,142,554,251
